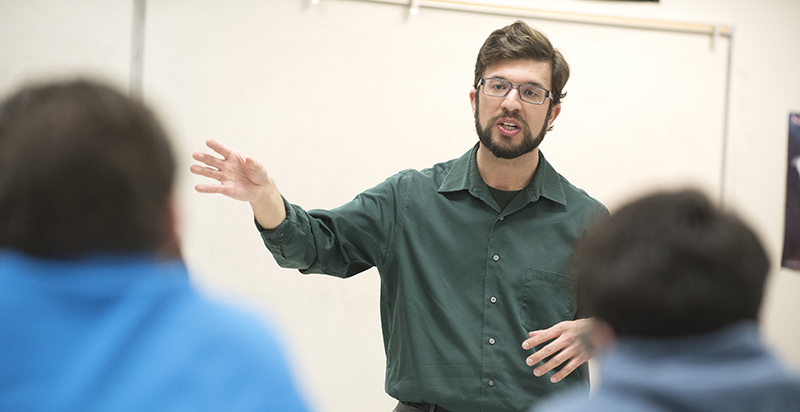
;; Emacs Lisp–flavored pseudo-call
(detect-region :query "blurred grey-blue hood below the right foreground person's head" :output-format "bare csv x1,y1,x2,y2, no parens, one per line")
599,322,800,412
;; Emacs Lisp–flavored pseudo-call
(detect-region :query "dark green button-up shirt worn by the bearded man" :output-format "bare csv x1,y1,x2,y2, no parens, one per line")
261,145,608,412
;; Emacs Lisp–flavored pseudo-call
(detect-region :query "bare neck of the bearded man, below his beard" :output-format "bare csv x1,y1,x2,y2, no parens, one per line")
476,145,539,191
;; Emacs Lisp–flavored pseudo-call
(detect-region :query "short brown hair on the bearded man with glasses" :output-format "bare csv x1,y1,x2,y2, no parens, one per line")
473,20,569,105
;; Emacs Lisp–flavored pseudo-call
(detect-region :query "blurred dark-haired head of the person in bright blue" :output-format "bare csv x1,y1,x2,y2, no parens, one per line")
0,80,176,258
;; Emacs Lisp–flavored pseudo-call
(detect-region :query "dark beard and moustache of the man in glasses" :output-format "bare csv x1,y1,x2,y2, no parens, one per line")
475,99,553,159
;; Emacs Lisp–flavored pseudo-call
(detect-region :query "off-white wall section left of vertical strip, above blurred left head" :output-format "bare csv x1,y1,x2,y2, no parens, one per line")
0,0,133,92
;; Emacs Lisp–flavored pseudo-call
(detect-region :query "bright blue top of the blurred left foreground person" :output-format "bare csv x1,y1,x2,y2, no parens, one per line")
0,249,307,412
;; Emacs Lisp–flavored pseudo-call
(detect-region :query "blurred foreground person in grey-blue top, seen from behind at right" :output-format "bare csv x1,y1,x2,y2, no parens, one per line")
535,190,800,412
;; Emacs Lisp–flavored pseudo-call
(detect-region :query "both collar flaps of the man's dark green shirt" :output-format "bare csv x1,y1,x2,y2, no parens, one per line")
439,143,567,205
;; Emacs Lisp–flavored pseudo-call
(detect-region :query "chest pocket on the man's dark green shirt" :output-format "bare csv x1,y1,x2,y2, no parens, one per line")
519,269,576,331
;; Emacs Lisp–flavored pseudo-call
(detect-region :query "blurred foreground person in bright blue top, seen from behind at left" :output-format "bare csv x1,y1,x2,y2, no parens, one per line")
0,79,307,412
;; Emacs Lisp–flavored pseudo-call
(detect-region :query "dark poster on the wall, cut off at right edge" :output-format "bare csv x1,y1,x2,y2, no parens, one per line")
781,113,800,270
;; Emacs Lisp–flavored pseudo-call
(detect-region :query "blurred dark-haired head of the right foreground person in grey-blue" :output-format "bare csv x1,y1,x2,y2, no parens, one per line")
577,190,769,337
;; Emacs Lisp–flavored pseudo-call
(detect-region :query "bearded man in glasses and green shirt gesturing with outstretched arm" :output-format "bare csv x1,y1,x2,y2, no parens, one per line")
191,21,607,412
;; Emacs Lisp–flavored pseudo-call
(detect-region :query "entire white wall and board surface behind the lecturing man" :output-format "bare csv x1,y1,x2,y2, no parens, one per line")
0,0,800,412
